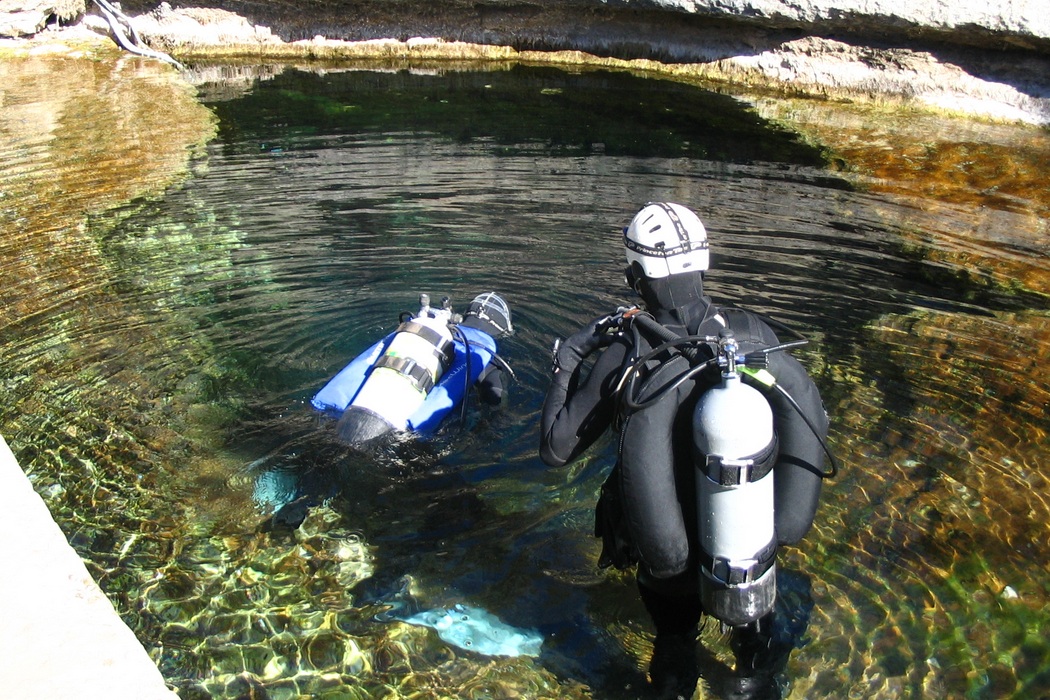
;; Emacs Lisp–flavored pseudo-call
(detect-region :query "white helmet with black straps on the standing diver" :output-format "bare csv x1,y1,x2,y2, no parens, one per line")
624,201,710,279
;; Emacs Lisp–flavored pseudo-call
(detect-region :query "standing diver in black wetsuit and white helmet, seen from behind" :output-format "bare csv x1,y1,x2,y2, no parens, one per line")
540,203,834,697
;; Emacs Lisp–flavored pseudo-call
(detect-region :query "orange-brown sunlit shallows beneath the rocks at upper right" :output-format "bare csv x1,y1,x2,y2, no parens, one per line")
757,100,1050,296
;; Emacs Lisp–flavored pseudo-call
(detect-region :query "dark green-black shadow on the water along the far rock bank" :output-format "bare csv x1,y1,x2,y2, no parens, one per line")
202,66,825,166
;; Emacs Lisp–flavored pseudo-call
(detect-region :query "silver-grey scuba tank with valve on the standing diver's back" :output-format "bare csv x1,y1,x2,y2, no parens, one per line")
693,332,777,627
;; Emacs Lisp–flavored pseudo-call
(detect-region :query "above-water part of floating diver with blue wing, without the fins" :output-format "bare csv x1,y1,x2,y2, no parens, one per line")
312,292,513,445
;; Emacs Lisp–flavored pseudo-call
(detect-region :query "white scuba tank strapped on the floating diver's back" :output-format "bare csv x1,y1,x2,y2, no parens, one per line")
336,294,455,443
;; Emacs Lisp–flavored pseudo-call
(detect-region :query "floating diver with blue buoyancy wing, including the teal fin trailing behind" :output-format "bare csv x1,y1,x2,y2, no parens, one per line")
251,292,513,528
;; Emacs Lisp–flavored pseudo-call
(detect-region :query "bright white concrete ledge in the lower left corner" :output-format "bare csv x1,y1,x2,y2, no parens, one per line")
0,437,179,700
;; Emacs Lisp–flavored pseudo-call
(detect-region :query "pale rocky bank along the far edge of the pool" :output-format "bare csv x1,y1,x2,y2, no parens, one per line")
0,0,1050,126
